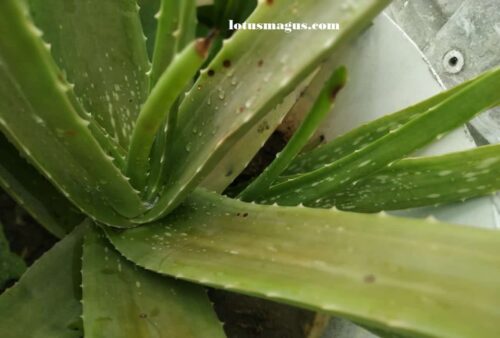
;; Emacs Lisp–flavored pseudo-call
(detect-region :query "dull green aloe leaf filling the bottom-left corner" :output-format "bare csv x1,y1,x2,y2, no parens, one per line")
0,225,86,338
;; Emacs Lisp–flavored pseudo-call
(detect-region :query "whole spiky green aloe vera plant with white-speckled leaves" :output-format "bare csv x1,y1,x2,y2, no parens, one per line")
0,0,500,338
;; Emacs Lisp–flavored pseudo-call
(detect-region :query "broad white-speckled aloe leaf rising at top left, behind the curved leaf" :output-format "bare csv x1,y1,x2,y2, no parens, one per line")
28,0,150,149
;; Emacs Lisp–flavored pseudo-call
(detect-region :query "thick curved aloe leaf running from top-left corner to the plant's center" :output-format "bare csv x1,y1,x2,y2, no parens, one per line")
0,0,144,226
